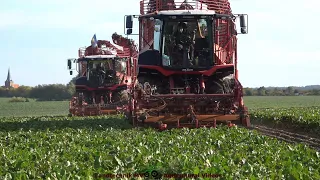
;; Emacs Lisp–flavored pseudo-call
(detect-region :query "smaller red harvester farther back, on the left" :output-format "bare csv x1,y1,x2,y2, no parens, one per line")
68,33,137,116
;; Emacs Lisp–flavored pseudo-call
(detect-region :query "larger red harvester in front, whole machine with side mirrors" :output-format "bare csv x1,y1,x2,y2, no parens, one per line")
125,0,250,129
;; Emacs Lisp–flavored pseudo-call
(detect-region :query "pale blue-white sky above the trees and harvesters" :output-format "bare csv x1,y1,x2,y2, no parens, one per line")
0,0,320,87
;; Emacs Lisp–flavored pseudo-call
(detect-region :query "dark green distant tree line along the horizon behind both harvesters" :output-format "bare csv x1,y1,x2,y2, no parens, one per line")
0,78,320,101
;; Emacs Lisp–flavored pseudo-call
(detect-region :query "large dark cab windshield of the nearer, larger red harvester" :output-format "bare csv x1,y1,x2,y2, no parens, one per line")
162,19,213,68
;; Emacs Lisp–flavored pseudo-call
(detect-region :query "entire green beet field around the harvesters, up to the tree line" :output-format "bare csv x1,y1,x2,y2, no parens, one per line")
0,96,320,180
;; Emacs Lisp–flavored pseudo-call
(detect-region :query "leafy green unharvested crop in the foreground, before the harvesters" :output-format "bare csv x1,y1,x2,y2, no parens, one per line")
0,116,320,179
